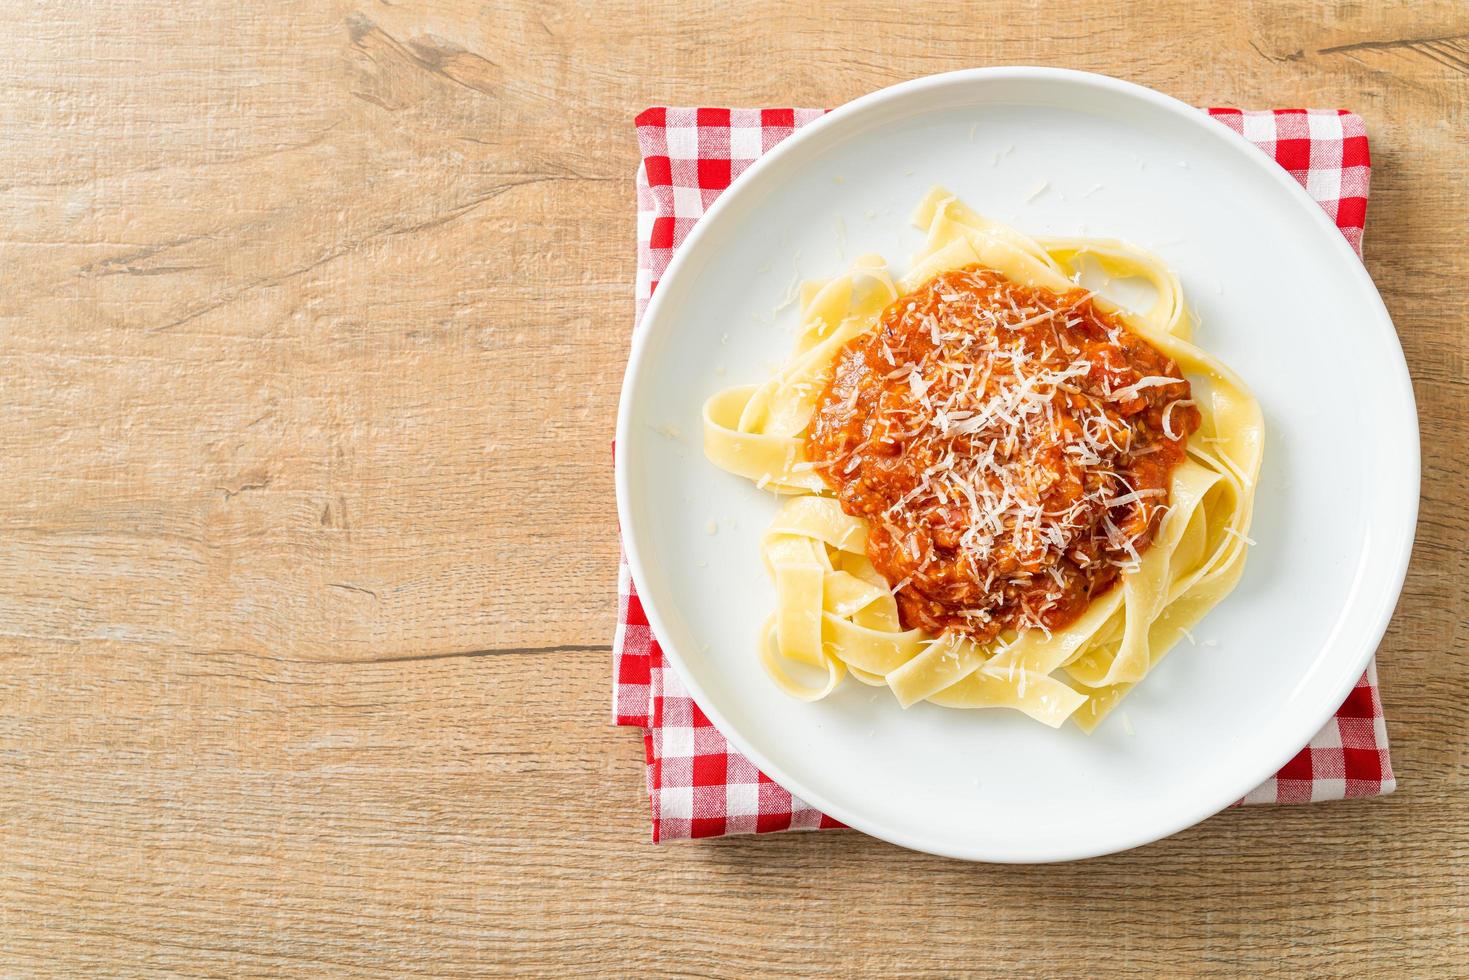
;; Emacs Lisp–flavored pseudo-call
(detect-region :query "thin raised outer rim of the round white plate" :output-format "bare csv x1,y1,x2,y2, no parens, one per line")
614,66,1422,864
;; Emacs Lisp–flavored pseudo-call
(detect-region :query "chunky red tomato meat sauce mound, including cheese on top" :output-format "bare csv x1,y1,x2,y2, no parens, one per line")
805,266,1200,642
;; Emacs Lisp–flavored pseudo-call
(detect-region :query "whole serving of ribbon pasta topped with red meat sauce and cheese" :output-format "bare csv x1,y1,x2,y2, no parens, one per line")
704,188,1263,732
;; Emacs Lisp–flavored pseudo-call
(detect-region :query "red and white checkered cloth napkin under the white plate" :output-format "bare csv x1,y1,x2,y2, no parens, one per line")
613,107,1396,840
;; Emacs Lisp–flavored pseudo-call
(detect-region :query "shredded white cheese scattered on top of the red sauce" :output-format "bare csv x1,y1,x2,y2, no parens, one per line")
824,265,1191,635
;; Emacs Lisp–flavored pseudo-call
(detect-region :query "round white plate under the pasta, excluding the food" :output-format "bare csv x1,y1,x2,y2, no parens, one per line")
617,68,1419,861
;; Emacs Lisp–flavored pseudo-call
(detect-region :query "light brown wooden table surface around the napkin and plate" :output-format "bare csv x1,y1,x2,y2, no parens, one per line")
0,0,1469,977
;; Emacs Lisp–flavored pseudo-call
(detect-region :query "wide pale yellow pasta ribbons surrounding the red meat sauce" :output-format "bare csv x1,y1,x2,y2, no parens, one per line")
704,188,1263,732
